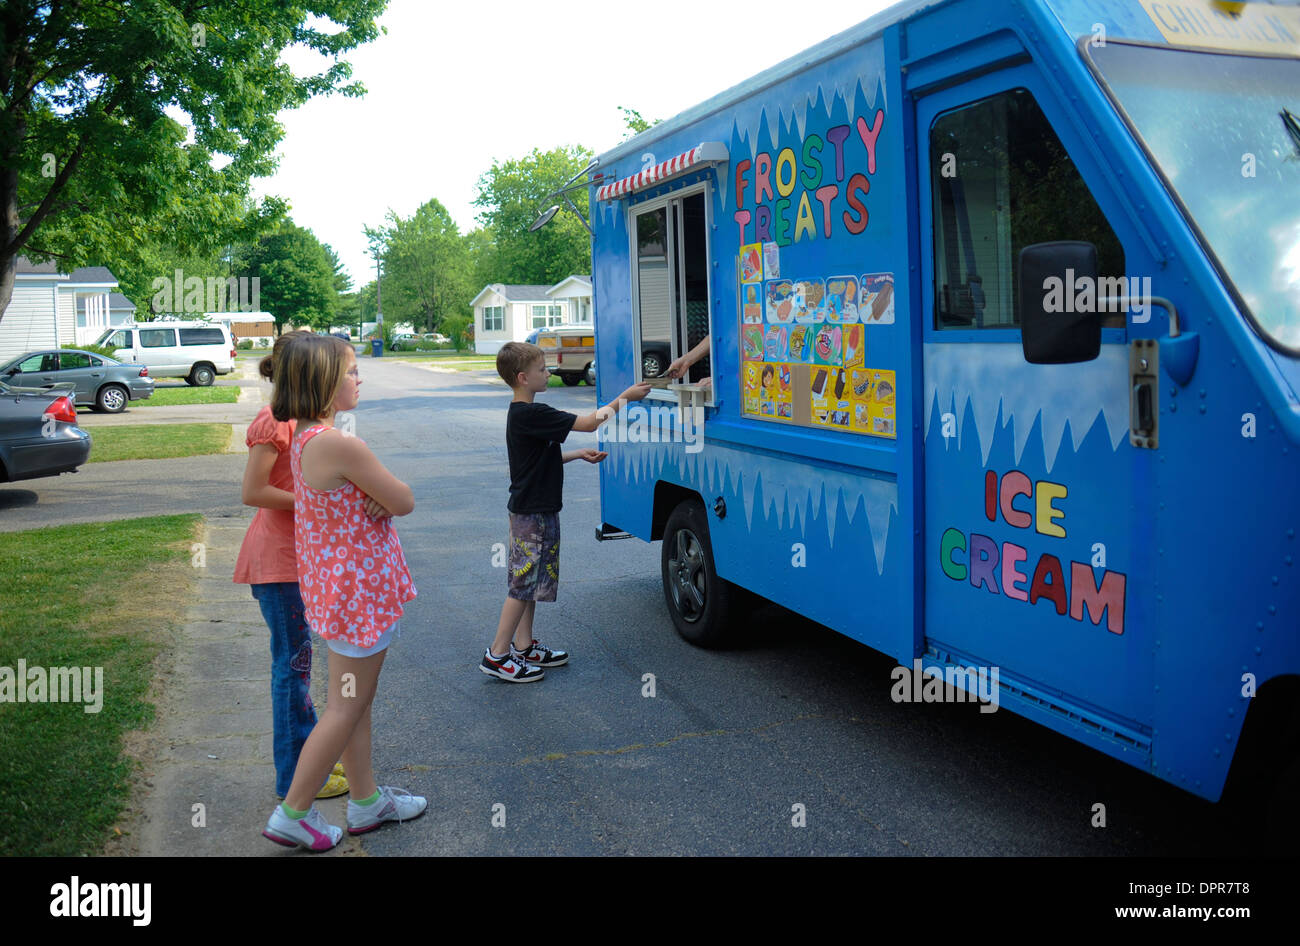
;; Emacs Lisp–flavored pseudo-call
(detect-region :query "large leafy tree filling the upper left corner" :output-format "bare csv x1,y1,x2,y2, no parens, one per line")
0,0,387,313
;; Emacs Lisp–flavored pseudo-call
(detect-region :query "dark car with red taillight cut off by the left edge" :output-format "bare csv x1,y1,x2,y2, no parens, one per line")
0,381,91,482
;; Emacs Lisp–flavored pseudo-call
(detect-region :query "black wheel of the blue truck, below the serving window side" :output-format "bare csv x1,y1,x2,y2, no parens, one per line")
660,500,740,647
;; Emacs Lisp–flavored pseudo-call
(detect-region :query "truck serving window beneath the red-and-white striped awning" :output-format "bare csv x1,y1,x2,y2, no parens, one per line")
633,191,712,381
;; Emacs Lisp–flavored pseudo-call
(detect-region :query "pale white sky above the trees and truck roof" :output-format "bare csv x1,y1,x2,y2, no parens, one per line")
254,0,891,287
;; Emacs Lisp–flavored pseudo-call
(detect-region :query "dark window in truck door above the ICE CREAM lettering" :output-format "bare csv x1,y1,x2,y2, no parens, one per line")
930,88,1125,329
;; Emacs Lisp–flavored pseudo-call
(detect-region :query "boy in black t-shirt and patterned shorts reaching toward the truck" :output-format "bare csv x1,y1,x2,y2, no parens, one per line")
478,342,650,684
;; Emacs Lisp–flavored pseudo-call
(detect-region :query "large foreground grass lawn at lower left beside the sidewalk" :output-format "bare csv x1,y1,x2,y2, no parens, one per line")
0,516,199,858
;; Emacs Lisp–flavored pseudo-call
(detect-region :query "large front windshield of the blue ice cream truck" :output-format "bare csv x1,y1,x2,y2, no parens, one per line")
1088,42,1300,355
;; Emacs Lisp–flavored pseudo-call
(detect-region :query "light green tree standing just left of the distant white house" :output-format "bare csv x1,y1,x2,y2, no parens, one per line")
365,200,473,331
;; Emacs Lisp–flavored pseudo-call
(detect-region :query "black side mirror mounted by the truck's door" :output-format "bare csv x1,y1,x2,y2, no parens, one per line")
1017,240,1101,365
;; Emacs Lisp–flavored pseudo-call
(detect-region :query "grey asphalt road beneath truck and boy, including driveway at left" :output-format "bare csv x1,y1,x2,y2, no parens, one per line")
0,359,1268,855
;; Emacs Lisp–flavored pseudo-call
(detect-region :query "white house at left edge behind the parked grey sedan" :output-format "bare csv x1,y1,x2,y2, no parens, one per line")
0,257,135,359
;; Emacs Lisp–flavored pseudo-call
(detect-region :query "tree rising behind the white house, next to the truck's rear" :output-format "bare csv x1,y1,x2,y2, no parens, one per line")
475,146,592,286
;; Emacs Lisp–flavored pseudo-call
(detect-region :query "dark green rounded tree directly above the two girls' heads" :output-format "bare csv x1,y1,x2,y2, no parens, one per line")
248,224,338,334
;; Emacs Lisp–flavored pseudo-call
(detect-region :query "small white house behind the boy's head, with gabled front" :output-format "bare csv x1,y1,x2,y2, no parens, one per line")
469,275,592,355
